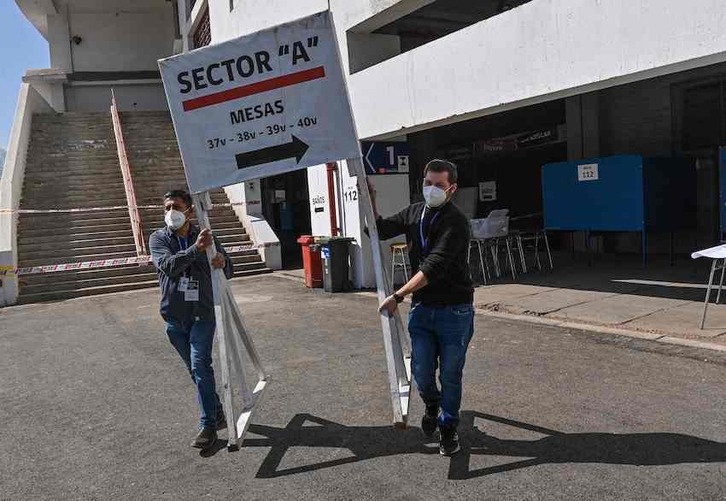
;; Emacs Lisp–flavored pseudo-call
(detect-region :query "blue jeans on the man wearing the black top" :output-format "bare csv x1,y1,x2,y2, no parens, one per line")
408,303,474,426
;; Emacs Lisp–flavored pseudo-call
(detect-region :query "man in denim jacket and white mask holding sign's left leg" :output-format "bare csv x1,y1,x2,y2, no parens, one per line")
149,190,233,450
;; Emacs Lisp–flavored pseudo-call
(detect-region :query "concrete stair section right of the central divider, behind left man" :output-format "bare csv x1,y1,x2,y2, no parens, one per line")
121,111,271,277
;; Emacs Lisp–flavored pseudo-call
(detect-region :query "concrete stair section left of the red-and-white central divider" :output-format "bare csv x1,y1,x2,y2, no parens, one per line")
18,113,156,303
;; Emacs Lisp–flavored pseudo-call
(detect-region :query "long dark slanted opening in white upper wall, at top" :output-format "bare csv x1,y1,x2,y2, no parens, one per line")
348,0,532,73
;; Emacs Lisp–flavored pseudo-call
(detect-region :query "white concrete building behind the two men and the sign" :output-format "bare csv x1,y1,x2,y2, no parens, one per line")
0,0,726,300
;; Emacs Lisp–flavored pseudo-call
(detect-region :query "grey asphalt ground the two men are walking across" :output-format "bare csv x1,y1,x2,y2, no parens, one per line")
0,275,726,500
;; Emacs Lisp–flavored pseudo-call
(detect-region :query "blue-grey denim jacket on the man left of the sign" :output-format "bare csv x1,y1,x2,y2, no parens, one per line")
149,226,234,323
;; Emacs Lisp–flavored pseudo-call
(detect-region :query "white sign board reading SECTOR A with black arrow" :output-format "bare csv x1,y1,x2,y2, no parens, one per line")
159,12,360,193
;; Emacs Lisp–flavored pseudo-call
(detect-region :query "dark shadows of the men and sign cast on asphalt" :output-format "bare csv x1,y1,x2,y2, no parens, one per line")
232,411,726,480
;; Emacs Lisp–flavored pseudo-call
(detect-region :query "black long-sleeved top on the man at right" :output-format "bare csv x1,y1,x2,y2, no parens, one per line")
377,202,474,306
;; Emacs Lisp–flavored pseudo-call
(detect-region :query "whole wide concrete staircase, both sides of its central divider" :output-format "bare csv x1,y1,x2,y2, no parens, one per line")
18,112,270,304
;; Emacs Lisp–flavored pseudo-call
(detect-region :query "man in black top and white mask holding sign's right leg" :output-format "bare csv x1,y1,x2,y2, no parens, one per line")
371,160,474,456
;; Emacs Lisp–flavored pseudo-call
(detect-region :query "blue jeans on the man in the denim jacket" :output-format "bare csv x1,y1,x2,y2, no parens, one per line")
166,320,222,428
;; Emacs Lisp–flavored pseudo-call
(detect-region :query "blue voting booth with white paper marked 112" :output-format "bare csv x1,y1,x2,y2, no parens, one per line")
542,155,696,263
